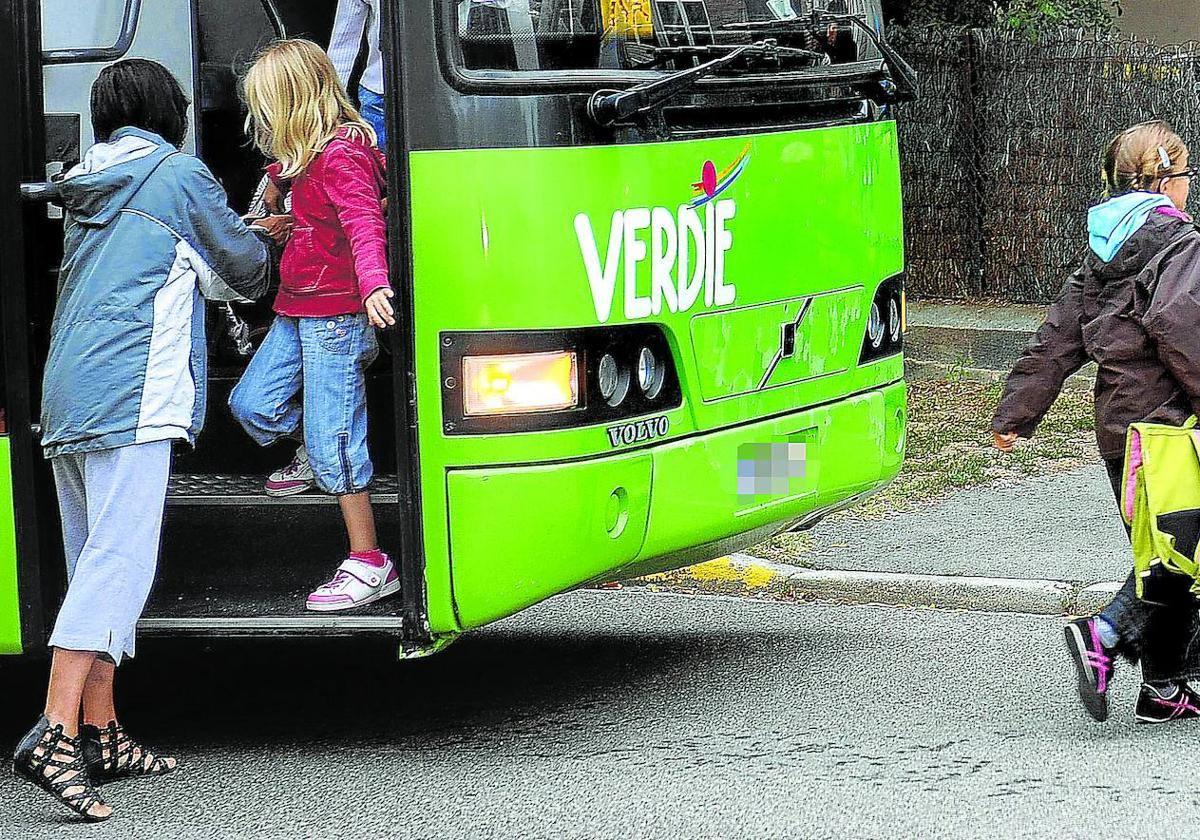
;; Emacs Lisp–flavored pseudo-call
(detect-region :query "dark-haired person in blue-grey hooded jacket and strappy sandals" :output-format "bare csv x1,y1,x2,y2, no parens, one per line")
13,59,278,821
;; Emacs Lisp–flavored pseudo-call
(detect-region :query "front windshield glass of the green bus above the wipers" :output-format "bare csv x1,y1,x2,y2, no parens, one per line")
455,0,882,73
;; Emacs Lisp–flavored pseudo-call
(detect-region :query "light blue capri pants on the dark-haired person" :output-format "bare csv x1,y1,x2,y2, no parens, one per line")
50,440,172,665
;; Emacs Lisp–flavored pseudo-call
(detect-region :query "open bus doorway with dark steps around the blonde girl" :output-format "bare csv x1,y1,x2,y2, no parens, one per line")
25,0,410,634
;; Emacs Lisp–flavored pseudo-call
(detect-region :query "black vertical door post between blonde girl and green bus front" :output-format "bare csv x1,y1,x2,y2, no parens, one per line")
379,0,432,647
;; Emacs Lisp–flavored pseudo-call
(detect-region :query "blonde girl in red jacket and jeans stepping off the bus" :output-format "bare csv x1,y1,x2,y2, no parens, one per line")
229,40,400,612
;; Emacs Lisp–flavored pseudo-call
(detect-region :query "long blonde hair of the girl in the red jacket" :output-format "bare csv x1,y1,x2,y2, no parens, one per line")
245,38,378,178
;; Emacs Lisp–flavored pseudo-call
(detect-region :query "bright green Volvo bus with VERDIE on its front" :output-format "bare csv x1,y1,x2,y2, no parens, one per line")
0,0,916,655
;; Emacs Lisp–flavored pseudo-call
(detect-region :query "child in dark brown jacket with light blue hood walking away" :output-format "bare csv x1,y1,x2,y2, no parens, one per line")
992,121,1200,724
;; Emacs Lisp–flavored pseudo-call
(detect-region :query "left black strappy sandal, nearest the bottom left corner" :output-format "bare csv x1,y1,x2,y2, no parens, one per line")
12,716,112,822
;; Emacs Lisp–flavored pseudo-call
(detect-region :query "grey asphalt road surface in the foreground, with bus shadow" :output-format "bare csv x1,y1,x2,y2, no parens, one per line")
0,590,1200,840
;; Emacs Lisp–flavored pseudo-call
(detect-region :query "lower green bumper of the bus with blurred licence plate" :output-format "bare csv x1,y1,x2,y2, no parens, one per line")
446,382,907,629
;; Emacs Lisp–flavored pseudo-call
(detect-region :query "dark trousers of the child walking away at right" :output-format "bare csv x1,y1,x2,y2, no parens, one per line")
1100,458,1200,683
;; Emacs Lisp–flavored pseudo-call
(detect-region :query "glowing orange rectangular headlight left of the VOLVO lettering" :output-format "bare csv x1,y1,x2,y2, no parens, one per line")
462,353,580,416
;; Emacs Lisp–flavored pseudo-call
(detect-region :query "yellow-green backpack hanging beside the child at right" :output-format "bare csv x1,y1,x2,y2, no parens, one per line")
1121,418,1200,601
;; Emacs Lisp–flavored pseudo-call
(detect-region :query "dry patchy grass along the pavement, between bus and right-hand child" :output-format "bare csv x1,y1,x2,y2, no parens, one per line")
757,371,1099,565
